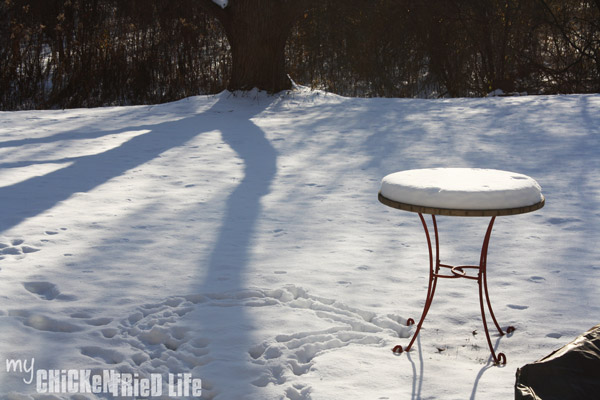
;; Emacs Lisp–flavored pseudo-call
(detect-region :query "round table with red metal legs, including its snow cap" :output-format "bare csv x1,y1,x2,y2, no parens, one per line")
378,168,545,365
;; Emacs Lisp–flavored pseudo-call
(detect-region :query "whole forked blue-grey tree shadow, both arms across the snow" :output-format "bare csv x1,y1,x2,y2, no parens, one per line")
0,95,277,394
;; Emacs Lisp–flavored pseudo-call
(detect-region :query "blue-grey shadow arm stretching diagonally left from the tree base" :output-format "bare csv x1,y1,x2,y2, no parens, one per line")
0,103,219,232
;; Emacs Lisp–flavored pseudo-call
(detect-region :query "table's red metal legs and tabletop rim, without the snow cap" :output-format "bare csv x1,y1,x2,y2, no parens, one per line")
379,193,545,365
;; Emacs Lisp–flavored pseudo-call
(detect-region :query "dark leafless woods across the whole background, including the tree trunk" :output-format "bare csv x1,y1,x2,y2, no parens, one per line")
0,0,600,110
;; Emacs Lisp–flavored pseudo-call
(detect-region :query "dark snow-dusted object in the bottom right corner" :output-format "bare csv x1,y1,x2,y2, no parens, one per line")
515,325,600,400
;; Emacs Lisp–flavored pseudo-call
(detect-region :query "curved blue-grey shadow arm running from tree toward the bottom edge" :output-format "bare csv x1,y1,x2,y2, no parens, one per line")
190,96,277,398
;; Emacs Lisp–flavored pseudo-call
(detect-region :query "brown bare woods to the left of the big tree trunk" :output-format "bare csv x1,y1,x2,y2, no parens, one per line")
0,0,230,109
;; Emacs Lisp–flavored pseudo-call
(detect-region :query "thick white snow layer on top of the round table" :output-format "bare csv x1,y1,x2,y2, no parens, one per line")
381,168,543,210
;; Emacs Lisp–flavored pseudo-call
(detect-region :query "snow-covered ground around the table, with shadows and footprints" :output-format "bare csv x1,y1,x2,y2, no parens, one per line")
0,90,600,400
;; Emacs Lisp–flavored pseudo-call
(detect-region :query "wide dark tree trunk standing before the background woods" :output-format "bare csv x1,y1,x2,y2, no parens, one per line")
204,0,310,93
